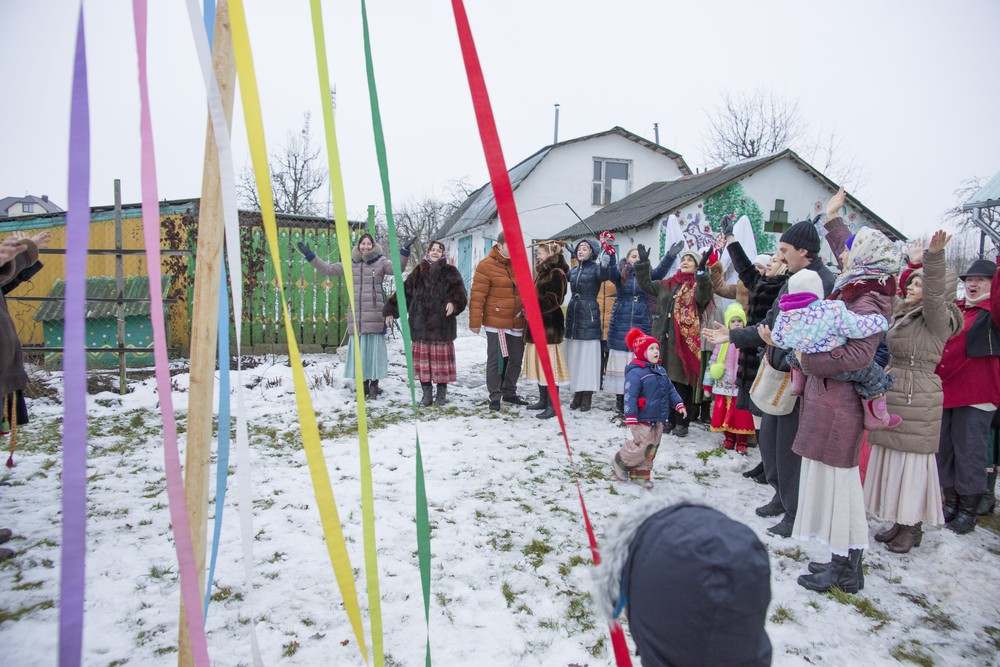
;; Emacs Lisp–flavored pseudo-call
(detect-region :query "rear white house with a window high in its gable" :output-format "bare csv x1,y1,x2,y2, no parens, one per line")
438,127,691,286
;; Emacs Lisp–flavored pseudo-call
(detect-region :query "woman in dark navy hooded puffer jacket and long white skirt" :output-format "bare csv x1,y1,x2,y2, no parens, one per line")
563,239,614,412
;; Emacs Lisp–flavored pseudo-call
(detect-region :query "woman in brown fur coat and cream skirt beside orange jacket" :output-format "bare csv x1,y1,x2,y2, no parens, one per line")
524,241,569,419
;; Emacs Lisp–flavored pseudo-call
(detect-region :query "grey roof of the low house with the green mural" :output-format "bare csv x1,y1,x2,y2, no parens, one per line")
554,149,906,240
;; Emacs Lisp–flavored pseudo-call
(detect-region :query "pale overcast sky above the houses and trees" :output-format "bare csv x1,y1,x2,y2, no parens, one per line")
0,0,1000,240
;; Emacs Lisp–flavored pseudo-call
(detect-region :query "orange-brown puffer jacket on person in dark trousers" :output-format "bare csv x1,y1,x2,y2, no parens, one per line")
469,245,524,330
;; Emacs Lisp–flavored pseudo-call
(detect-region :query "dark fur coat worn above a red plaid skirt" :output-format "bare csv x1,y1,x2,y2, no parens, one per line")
382,259,468,342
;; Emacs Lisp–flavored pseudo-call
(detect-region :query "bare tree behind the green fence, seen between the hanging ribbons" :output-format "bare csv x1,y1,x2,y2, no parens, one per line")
236,113,328,215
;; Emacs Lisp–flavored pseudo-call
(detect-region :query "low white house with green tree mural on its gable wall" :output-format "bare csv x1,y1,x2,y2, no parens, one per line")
553,150,906,268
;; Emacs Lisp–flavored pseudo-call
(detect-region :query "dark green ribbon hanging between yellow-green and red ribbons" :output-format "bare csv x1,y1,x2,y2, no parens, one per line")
361,0,431,667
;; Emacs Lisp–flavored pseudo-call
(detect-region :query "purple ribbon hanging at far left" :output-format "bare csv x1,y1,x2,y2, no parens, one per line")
59,7,90,667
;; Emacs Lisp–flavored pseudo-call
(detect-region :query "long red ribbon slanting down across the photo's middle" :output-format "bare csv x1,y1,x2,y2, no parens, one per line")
451,0,632,667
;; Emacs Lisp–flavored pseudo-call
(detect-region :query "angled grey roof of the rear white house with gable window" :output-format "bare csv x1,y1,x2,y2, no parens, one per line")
437,126,691,238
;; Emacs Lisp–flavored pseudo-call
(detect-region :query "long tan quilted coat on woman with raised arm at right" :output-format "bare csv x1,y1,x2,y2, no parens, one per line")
868,250,962,454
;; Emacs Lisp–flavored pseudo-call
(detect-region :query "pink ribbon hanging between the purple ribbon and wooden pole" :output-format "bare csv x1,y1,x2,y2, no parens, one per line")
132,0,209,666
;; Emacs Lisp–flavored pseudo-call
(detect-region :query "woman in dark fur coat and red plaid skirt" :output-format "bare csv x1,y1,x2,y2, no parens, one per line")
382,241,468,407
